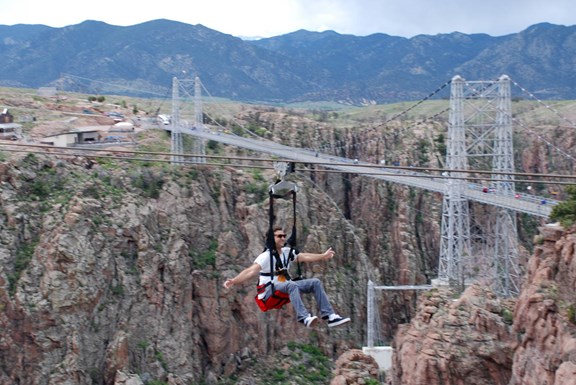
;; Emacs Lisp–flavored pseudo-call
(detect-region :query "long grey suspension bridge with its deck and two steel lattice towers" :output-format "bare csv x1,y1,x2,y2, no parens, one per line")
169,75,558,286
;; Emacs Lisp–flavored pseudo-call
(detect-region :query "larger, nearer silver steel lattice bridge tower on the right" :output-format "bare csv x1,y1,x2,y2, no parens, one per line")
438,75,520,296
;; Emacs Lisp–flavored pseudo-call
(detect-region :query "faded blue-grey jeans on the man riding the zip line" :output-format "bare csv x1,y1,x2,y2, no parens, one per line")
265,278,334,321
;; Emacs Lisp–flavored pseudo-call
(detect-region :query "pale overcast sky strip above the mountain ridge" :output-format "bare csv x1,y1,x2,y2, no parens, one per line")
0,0,576,37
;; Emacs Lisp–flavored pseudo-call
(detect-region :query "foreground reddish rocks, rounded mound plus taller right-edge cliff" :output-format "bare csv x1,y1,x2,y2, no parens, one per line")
389,227,576,385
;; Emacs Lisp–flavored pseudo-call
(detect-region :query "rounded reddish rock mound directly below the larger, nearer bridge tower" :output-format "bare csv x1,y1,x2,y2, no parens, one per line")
392,285,514,385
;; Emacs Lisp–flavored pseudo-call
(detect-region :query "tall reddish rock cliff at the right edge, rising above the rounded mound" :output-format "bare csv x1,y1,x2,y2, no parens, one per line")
509,227,576,385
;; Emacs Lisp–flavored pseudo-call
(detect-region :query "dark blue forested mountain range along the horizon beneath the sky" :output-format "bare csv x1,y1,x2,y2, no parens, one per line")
0,19,576,105
